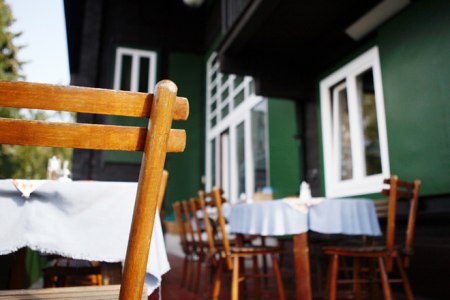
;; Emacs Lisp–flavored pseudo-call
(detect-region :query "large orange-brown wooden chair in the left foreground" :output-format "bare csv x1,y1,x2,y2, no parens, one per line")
0,80,189,300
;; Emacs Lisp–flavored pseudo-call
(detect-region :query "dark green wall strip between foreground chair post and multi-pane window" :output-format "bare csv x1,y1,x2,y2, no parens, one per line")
163,53,205,215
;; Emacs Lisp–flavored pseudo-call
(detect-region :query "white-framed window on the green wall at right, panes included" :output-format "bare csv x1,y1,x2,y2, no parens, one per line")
320,47,390,197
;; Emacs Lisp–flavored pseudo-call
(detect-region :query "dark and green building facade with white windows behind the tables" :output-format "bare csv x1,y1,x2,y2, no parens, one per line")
65,0,450,215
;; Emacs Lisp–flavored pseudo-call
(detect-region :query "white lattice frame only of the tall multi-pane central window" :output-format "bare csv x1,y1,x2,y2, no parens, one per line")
205,53,270,203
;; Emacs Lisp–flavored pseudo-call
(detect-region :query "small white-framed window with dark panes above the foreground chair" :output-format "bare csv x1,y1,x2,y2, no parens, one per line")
114,47,156,93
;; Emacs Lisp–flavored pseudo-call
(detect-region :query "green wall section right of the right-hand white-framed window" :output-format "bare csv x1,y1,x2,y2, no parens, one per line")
378,0,450,195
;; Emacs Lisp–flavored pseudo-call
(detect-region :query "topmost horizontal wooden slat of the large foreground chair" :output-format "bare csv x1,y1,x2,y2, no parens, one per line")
0,81,189,120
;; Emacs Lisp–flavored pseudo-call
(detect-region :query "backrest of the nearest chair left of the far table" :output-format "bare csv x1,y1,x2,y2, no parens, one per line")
198,187,233,270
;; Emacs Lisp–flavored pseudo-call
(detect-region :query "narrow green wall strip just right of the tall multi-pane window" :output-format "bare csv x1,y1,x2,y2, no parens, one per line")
269,98,303,199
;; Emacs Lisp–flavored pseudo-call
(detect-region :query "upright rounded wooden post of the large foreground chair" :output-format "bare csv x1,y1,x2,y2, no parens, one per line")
119,80,177,300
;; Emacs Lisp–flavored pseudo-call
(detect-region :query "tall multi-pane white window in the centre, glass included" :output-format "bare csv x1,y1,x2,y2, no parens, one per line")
206,53,269,202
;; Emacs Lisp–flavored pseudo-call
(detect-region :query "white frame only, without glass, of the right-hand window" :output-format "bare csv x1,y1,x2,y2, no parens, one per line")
320,47,390,197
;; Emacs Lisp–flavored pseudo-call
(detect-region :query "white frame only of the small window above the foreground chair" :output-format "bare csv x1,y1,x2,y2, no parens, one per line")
114,47,157,92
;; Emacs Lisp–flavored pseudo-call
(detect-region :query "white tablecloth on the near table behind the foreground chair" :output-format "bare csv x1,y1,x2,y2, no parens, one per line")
0,180,170,293
